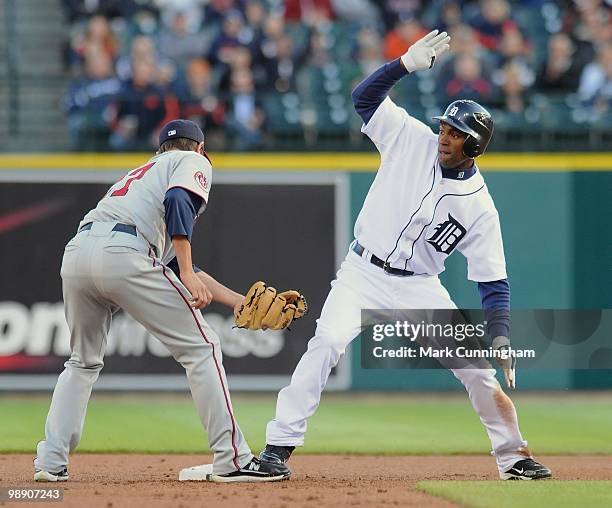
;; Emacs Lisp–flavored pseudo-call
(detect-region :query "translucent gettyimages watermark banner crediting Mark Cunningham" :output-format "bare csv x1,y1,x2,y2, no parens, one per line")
361,309,612,369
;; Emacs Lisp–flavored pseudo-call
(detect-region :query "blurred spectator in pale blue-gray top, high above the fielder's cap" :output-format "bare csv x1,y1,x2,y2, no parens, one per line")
159,11,208,69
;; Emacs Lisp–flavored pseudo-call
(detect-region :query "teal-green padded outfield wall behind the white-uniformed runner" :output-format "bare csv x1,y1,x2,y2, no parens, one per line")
351,171,612,390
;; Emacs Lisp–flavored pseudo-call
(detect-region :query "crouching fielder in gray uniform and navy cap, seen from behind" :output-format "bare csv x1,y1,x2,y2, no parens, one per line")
34,120,289,482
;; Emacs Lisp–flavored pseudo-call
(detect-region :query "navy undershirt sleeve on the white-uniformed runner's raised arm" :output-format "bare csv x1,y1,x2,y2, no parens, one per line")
352,58,408,124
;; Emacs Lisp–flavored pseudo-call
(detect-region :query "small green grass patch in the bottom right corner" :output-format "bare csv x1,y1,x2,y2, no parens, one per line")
417,480,612,508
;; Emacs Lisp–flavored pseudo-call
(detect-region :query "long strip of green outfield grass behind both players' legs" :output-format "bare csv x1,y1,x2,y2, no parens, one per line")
0,394,612,455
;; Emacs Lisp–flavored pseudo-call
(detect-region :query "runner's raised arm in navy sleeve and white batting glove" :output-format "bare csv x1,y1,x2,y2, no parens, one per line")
352,30,450,124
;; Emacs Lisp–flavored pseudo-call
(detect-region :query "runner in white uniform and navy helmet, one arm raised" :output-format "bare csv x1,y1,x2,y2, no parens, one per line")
260,30,551,480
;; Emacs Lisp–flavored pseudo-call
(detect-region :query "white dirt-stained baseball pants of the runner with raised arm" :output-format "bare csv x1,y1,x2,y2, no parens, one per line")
266,250,529,471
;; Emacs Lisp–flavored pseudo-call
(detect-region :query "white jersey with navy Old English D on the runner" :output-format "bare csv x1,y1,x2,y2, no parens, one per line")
355,97,506,282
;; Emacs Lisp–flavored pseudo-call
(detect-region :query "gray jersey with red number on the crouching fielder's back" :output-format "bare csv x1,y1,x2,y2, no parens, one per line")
79,150,212,263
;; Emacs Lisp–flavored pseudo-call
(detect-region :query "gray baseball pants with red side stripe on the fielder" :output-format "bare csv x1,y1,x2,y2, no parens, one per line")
34,222,253,474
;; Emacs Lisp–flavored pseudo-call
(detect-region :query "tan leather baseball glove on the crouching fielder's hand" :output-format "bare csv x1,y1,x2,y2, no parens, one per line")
234,281,308,330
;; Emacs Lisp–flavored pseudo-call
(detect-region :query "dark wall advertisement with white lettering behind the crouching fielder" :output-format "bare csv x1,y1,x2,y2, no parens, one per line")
0,175,344,390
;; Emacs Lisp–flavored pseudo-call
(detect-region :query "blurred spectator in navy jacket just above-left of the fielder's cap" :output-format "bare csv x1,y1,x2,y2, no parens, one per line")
110,60,166,150
